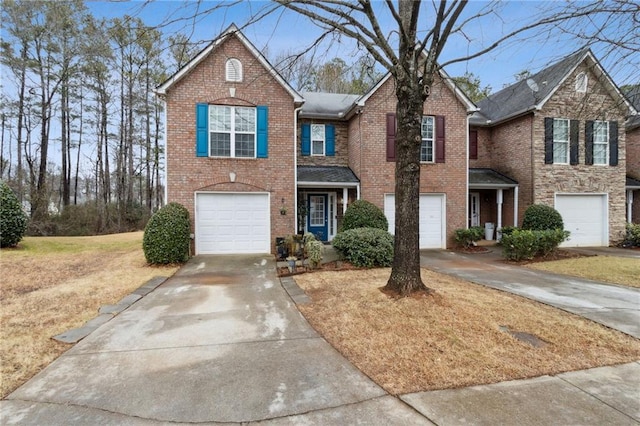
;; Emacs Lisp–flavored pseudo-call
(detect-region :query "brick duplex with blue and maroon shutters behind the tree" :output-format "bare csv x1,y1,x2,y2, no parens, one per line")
157,26,476,254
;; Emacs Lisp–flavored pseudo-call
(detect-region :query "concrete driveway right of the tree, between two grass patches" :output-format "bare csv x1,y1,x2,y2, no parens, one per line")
420,247,640,338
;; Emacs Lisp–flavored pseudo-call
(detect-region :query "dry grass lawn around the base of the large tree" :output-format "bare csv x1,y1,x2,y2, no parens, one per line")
295,269,640,394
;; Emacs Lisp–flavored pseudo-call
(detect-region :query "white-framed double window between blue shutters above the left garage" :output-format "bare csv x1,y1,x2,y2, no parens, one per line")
209,105,256,158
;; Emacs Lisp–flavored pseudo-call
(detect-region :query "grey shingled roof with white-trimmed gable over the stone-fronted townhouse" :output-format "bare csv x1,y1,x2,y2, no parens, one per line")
472,48,635,124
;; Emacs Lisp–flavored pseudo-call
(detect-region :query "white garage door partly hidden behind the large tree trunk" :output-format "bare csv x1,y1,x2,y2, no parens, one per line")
384,194,447,249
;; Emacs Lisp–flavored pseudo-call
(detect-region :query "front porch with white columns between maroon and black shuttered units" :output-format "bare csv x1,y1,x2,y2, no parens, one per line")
467,169,518,240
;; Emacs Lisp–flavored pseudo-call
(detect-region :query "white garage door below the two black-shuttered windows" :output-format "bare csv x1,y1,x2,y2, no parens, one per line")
556,194,609,247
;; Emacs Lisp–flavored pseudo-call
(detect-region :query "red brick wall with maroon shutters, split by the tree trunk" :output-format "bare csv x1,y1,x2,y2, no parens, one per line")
349,73,467,245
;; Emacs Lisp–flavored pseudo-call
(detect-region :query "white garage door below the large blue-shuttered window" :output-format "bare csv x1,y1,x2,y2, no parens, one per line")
195,193,271,254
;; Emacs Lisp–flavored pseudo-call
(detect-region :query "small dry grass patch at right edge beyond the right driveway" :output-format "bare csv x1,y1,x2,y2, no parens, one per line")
526,256,640,288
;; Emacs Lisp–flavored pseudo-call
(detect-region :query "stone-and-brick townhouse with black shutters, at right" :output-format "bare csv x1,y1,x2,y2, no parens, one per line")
470,49,637,246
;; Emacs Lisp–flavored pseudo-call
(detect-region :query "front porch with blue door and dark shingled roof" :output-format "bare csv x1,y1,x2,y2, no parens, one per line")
296,166,360,242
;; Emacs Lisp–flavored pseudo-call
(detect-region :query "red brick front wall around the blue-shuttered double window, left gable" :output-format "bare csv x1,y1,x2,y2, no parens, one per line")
166,36,295,253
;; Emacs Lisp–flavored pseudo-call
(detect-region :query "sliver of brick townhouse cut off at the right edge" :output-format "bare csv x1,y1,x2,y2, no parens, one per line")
625,85,640,223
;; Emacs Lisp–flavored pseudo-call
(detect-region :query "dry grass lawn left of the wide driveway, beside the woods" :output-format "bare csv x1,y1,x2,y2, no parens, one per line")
0,232,177,398
